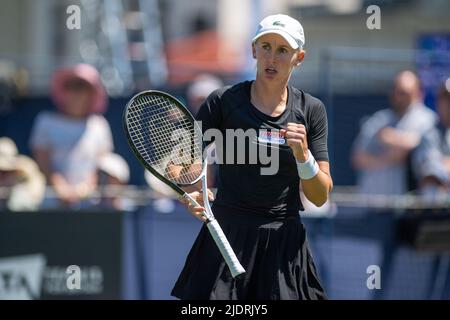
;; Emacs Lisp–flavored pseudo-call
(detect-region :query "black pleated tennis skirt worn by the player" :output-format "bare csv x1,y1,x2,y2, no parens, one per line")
172,206,326,300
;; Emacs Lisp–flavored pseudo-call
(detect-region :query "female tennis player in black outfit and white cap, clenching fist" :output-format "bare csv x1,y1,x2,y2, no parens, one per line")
172,15,333,300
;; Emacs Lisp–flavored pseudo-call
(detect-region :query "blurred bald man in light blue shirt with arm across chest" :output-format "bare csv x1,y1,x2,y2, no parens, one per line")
352,71,436,195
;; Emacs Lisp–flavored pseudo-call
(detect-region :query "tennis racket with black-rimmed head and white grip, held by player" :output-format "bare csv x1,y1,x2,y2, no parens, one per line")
123,90,245,278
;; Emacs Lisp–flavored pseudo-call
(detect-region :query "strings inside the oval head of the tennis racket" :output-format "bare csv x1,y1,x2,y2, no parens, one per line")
127,94,202,184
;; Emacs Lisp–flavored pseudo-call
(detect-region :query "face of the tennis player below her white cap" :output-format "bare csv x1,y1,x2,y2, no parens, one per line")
253,33,304,81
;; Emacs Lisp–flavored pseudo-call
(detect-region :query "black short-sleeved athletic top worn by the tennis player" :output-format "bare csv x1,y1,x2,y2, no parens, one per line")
197,81,328,217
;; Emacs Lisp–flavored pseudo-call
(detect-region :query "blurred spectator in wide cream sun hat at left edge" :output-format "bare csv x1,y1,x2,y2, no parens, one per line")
0,137,45,211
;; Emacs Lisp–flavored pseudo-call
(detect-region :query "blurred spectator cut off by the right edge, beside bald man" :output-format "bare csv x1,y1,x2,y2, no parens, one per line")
413,78,450,200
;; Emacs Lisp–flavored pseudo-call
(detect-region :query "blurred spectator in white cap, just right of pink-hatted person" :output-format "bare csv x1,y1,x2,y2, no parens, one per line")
98,153,130,210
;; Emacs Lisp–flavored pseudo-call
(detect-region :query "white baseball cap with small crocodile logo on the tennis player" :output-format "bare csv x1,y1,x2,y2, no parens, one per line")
252,14,305,49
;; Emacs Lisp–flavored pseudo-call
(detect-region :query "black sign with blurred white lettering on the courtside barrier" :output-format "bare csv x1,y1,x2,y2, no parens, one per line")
0,211,124,300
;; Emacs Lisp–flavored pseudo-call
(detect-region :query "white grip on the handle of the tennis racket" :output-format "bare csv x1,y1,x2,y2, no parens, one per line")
206,219,245,278
